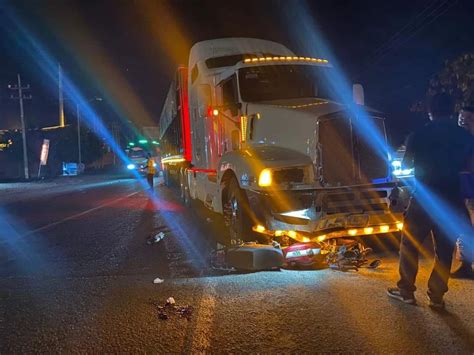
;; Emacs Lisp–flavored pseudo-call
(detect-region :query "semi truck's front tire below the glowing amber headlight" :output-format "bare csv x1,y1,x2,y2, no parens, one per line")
224,177,257,244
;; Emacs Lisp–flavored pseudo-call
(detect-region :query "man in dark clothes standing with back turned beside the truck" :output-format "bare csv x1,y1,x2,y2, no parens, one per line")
387,93,473,308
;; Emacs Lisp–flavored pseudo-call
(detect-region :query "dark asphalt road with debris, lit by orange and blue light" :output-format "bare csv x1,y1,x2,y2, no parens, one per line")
0,176,474,354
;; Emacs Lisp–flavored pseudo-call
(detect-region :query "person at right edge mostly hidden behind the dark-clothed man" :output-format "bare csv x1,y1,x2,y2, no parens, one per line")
451,106,474,278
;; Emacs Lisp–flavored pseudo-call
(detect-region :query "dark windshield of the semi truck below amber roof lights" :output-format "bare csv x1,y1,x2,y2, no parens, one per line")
239,65,334,102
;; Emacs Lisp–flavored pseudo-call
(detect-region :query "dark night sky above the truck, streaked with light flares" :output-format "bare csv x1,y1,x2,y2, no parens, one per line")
0,0,474,142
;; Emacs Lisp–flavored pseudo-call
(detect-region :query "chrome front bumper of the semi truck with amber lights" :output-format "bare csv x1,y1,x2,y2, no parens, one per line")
247,183,410,242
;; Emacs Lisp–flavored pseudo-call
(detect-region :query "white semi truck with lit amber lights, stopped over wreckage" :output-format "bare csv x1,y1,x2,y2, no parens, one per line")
160,38,408,243
